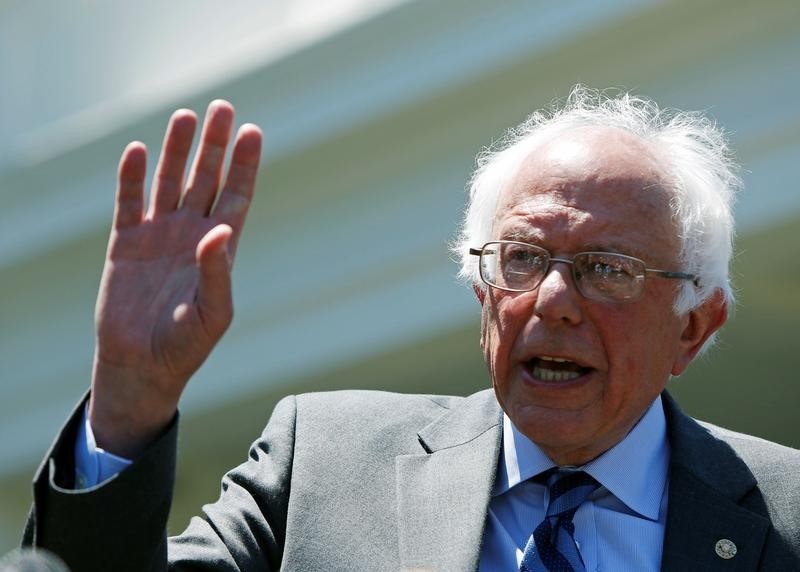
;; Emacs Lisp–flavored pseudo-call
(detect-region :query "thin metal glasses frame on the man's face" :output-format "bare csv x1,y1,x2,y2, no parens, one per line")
469,240,700,302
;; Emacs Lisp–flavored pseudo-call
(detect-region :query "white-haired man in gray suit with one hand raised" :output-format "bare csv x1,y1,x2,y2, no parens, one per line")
21,87,800,571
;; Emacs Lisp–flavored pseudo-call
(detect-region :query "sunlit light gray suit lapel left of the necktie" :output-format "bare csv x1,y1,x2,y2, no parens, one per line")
395,391,502,571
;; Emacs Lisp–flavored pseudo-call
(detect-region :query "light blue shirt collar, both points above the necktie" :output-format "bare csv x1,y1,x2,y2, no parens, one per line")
492,396,669,520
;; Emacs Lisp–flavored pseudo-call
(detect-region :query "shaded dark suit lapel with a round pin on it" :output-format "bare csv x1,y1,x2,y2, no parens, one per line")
661,393,770,571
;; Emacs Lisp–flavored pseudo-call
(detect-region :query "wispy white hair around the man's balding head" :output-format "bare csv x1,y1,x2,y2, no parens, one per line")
453,85,741,315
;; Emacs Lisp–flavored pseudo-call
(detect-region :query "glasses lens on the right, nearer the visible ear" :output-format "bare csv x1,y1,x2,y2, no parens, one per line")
574,252,645,302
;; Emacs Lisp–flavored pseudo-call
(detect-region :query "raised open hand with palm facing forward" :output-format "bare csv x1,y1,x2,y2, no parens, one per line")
89,101,261,457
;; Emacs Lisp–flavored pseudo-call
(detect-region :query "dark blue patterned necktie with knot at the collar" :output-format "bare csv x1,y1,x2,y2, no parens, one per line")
519,468,600,572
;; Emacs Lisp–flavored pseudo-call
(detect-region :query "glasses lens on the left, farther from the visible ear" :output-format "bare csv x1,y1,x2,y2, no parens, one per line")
481,242,549,291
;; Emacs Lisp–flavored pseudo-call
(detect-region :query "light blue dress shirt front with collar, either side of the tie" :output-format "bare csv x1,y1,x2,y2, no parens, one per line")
479,396,669,572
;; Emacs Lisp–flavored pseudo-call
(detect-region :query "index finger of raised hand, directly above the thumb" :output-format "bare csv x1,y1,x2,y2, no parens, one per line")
214,123,262,257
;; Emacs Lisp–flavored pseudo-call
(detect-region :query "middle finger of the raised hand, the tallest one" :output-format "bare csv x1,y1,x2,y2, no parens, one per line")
183,99,233,214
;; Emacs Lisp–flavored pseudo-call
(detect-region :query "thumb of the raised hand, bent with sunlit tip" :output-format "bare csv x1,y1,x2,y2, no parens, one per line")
195,224,233,339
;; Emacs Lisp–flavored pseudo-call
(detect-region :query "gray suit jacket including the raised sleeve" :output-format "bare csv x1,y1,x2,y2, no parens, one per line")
25,391,800,572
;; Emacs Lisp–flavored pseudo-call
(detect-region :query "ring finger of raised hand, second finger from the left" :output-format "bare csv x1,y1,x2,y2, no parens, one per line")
149,109,197,216
